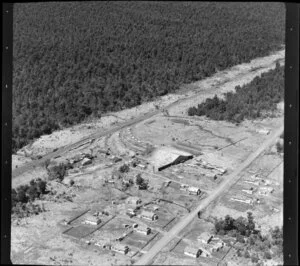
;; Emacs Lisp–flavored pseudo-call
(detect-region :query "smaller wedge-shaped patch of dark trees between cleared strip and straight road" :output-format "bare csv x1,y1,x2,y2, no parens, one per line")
188,64,284,123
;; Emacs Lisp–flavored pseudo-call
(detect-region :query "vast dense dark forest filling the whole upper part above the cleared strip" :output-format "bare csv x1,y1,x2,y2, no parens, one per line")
13,1,285,151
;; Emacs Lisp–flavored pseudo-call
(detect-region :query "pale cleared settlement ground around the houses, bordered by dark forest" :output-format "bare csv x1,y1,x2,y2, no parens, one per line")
11,51,284,265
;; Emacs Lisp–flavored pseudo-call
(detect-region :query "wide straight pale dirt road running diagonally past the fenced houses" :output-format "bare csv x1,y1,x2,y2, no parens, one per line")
135,126,283,265
